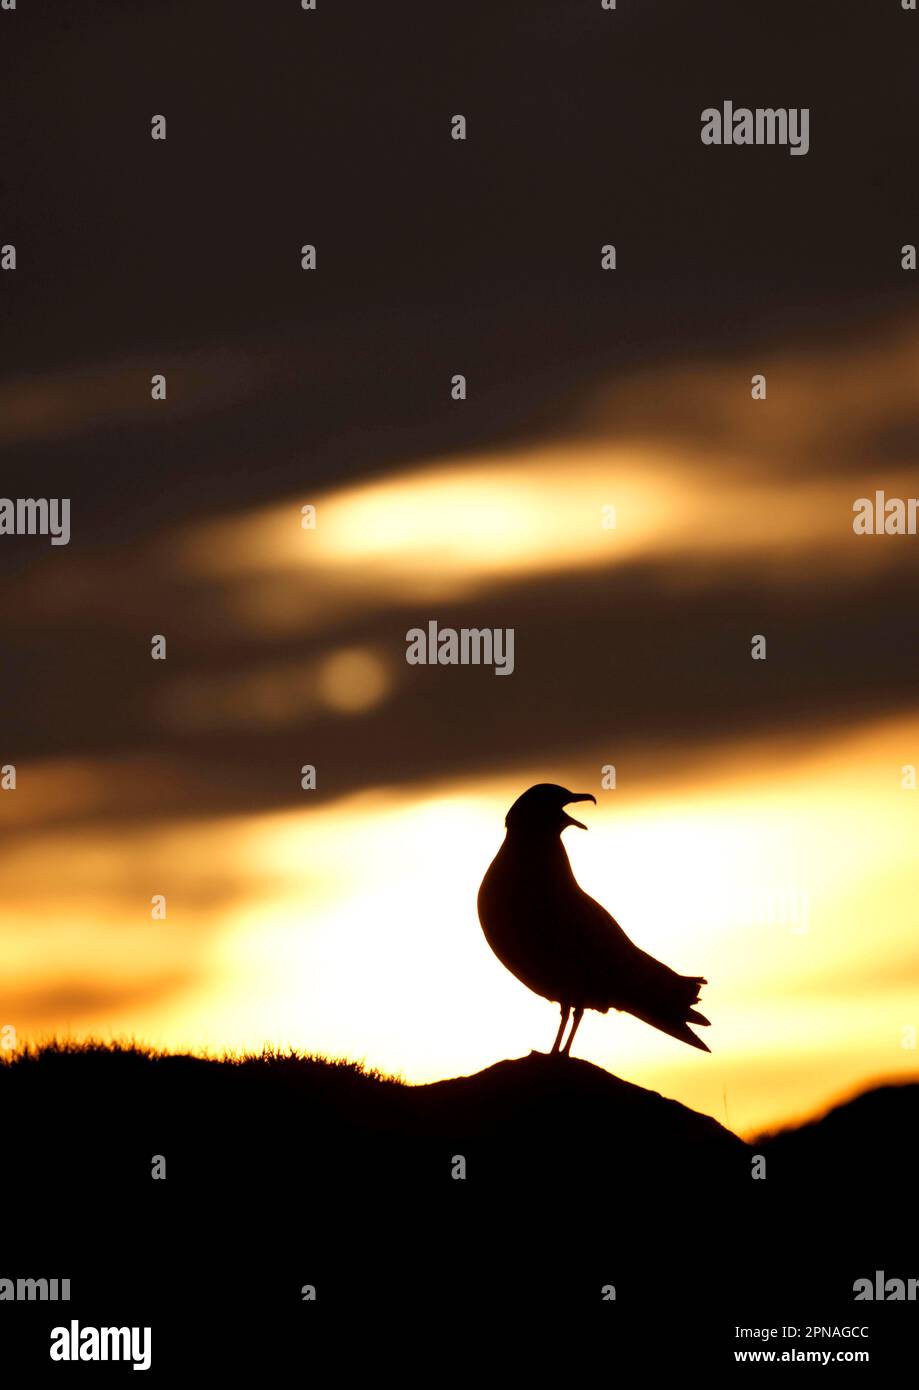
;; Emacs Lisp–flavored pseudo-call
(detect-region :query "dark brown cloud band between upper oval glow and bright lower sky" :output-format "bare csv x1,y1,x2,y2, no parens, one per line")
6,547,919,828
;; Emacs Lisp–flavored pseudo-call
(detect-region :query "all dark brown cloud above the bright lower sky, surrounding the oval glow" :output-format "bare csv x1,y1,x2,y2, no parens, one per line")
0,0,919,834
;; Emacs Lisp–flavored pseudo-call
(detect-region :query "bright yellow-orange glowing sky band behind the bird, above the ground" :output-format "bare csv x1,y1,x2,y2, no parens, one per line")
0,720,919,1133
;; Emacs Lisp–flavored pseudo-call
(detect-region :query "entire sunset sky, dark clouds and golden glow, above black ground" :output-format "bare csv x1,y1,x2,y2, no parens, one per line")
0,0,919,1134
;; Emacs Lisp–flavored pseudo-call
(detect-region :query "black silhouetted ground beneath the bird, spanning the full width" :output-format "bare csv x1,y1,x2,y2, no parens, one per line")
0,1047,919,1305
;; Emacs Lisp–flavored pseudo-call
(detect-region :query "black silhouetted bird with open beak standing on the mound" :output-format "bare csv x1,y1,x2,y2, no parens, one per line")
478,783,709,1055
